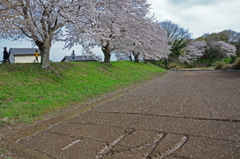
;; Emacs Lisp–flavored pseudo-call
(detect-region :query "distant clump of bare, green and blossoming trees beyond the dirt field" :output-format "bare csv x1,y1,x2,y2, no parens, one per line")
154,21,240,66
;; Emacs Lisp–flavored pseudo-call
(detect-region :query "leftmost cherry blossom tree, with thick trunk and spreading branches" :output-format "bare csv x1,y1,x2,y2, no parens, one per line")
0,0,95,68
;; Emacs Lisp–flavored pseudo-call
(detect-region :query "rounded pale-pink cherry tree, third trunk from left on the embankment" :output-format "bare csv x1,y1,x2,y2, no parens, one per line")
105,16,170,62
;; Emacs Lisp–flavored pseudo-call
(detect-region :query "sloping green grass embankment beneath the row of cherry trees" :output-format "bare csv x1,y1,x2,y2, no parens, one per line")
0,62,166,123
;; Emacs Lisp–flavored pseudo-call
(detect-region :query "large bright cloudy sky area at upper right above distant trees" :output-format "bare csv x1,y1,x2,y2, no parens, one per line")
148,0,240,38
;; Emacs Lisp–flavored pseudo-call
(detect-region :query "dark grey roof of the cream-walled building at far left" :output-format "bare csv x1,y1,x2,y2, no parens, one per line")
9,48,40,56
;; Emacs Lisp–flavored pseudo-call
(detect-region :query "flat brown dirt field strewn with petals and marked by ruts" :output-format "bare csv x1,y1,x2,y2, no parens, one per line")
0,71,240,159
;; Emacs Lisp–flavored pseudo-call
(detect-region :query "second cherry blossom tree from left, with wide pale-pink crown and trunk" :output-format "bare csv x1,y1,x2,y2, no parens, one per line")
66,0,153,65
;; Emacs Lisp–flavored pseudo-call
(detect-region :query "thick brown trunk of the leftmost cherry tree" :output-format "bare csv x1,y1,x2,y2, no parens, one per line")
35,38,52,69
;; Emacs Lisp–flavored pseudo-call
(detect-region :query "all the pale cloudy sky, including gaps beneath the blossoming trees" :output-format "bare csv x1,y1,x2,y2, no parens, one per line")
0,0,240,61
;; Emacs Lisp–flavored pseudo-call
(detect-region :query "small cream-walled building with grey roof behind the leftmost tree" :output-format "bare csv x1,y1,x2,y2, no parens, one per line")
9,48,41,63
